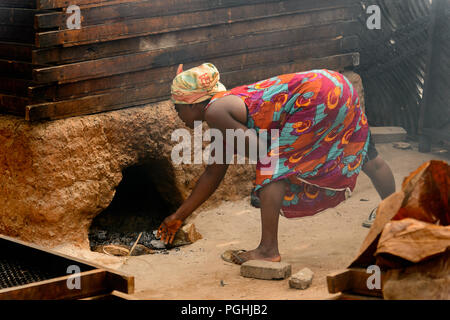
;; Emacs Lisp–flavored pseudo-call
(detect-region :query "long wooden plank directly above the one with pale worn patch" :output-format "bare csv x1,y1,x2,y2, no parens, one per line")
36,0,358,47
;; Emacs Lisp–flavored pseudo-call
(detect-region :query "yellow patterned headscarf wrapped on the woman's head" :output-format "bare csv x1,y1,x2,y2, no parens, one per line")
171,63,227,104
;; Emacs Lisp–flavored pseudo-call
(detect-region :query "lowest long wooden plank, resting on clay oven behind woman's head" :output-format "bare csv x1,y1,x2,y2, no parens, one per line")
25,54,357,121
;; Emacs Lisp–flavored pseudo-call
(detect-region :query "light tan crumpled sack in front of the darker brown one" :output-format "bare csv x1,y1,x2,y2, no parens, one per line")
375,218,450,267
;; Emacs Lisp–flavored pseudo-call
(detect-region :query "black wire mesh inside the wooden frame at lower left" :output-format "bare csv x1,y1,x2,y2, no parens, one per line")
0,257,60,289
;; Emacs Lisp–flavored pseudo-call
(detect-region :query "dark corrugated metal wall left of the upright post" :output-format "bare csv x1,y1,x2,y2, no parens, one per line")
356,0,430,134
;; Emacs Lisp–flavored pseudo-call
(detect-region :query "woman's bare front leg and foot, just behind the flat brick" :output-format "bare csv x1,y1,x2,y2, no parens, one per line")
232,180,286,262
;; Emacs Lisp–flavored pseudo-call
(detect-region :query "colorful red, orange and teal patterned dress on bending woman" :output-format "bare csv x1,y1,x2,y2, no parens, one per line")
207,70,369,218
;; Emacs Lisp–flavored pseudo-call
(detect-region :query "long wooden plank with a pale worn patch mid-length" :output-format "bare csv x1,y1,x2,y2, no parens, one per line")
33,7,359,65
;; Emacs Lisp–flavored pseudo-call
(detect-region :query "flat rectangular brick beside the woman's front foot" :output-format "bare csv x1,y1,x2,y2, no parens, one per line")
241,260,292,280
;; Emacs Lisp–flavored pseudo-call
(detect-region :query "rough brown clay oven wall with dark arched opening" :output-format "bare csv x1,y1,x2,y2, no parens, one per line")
0,102,254,248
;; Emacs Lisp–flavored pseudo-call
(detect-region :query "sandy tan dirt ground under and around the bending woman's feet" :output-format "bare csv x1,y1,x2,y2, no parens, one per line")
59,143,449,300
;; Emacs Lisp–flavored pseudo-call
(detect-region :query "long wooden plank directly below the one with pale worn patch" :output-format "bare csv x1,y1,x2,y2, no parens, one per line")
33,22,356,83
